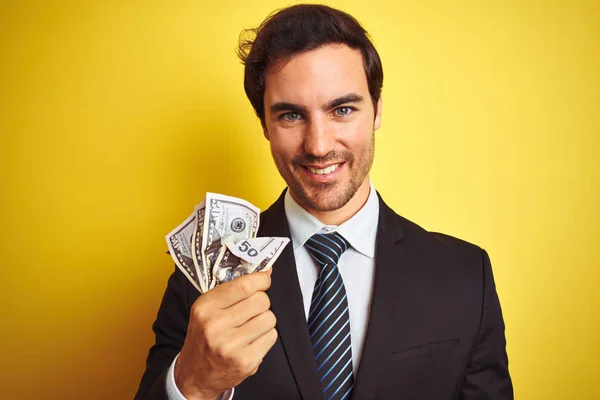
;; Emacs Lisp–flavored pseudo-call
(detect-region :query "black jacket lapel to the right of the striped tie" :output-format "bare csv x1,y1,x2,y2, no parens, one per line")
352,193,407,400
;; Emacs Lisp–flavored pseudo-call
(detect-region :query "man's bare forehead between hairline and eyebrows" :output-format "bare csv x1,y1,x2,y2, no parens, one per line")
264,44,369,109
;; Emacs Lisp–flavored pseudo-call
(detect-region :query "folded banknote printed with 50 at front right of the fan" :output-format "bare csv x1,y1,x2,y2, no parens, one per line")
213,237,290,286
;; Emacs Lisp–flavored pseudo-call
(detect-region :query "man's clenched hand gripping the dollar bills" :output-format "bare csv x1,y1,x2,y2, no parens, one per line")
175,270,277,400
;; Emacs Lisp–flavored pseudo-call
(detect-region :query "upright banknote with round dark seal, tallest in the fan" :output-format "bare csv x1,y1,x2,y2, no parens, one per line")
201,193,260,290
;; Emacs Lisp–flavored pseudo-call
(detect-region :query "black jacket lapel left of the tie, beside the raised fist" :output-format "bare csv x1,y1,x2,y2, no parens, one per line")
259,191,323,400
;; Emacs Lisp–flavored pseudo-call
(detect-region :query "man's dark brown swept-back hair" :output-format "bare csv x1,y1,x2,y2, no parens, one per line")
238,4,383,125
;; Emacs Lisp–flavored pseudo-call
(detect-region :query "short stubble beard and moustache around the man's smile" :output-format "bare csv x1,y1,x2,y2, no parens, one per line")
271,134,375,212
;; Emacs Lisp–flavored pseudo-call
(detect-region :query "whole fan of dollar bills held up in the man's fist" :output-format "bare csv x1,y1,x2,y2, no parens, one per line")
166,193,290,293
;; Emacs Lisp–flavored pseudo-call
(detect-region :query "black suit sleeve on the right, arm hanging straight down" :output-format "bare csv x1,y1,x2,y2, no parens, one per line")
461,250,514,400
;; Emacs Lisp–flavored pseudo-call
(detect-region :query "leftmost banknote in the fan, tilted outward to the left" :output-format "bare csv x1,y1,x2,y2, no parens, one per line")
165,213,200,290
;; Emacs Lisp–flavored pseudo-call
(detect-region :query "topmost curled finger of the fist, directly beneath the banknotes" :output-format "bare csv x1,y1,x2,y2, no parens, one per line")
201,272,271,309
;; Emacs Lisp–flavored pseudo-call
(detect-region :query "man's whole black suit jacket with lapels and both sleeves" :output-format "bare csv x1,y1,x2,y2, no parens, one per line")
135,195,513,400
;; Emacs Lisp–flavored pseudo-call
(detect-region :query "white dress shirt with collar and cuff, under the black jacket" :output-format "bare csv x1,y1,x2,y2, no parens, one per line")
166,183,379,400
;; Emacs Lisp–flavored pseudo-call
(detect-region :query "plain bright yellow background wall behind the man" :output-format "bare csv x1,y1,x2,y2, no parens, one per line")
0,0,600,400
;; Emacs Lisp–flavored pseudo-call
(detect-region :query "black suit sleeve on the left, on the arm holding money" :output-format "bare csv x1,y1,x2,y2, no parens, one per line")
135,268,196,400
